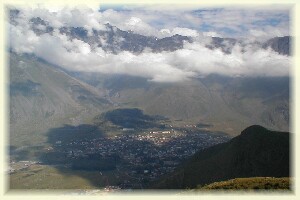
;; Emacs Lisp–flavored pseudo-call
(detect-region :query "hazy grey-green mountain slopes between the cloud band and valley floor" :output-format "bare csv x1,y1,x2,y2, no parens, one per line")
10,53,289,155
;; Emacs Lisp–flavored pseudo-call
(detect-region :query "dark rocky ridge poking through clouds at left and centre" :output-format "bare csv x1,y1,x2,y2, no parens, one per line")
30,17,192,54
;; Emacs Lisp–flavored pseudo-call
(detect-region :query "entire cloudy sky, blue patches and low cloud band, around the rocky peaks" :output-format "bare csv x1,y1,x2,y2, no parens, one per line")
8,5,291,82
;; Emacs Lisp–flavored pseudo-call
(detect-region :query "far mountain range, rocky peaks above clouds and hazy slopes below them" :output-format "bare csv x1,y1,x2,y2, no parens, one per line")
10,10,291,147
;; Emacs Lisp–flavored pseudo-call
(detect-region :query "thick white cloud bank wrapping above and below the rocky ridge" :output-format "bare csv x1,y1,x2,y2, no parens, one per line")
10,6,291,82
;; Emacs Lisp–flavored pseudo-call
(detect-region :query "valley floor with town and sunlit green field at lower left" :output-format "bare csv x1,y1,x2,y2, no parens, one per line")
9,125,230,189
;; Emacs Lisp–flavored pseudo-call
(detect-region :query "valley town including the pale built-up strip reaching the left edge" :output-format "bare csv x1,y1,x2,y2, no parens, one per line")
9,125,230,191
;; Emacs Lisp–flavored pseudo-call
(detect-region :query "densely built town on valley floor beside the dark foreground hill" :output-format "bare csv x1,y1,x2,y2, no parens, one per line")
53,128,230,189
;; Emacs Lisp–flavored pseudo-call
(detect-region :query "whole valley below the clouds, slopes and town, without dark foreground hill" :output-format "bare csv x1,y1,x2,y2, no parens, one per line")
9,50,289,190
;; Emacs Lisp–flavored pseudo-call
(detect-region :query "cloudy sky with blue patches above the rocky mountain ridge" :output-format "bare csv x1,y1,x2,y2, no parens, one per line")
9,5,291,40
